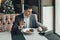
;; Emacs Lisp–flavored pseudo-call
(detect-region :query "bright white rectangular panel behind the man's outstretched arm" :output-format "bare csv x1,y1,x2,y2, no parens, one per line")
43,6,53,31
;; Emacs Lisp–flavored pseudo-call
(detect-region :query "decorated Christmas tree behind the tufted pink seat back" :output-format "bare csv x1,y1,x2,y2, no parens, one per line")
2,0,15,14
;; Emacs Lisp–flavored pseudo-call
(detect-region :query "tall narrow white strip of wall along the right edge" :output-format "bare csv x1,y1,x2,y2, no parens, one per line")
55,0,60,35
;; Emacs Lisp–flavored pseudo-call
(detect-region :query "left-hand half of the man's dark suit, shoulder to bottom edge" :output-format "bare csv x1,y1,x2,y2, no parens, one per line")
11,15,26,40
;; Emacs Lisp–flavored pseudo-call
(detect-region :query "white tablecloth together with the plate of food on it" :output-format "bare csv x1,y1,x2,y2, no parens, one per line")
23,28,48,40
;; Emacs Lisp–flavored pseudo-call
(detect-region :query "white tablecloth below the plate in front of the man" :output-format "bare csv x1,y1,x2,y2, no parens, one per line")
24,29,48,40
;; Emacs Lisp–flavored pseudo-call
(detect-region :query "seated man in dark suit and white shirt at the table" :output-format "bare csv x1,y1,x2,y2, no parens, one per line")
11,5,47,40
